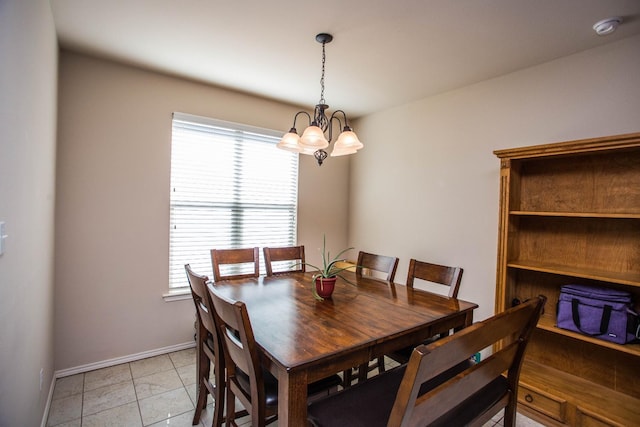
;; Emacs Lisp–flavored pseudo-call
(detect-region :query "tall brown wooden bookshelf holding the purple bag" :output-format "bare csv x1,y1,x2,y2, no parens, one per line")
495,133,640,426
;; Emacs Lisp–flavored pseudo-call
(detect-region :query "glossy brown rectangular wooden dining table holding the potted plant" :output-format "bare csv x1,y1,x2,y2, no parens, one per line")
209,272,477,427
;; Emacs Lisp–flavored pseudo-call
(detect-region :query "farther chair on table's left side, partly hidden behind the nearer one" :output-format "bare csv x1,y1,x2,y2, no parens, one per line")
184,264,224,426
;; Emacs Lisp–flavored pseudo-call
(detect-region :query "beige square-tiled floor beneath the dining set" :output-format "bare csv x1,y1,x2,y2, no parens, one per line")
47,348,541,427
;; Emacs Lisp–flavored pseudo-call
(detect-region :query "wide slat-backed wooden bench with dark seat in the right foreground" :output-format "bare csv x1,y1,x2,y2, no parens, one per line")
308,296,546,427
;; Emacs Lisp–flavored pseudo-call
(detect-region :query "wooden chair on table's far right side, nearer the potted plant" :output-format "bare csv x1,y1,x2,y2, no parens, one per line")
342,251,399,387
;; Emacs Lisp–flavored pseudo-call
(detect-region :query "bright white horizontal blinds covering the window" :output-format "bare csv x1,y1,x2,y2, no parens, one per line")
169,113,298,289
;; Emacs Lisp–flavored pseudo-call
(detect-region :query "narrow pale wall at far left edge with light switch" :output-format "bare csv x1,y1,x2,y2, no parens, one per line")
0,0,58,426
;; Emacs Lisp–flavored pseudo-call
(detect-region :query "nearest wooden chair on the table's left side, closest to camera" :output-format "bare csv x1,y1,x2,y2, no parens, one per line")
209,286,341,427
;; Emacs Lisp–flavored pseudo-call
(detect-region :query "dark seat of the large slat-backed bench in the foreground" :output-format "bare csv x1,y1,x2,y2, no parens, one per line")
308,360,484,427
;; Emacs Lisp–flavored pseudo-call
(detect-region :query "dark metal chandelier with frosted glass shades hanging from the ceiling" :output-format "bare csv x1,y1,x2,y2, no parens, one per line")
277,33,363,166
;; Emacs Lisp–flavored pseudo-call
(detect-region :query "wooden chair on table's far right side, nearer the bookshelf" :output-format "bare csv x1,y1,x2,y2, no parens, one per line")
387,258,464,363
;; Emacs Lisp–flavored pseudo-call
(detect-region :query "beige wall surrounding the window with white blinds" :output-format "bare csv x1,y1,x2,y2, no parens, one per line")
55,51,349,370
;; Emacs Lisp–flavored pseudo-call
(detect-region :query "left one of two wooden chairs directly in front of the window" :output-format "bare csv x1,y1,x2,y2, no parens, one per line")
211,247,260,282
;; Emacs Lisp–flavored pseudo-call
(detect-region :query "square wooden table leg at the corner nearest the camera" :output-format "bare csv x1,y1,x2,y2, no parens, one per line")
278,372,307,427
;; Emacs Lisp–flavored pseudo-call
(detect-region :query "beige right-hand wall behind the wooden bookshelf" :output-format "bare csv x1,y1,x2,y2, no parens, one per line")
349,36,640,319
